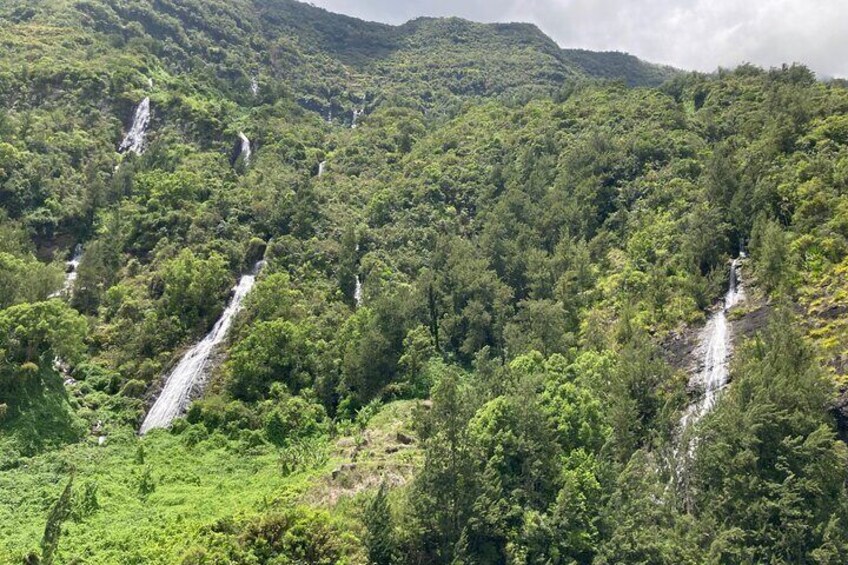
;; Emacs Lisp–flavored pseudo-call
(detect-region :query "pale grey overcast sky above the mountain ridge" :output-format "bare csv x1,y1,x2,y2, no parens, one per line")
313,0,848,77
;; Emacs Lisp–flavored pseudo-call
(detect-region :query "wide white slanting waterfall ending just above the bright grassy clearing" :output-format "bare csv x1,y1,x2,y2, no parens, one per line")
139,261,263,435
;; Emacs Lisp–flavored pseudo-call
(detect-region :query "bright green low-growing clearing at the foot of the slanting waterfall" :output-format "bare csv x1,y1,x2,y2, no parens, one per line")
0,429,330,564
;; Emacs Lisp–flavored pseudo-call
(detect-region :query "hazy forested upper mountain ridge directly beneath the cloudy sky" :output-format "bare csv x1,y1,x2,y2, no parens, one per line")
0,0,674,120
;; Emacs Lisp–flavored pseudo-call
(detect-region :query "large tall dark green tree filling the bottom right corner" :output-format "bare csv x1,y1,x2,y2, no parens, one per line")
691,310,848,563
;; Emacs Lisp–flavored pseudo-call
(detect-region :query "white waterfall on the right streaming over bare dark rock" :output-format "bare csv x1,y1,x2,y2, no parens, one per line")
681,255,745,430
